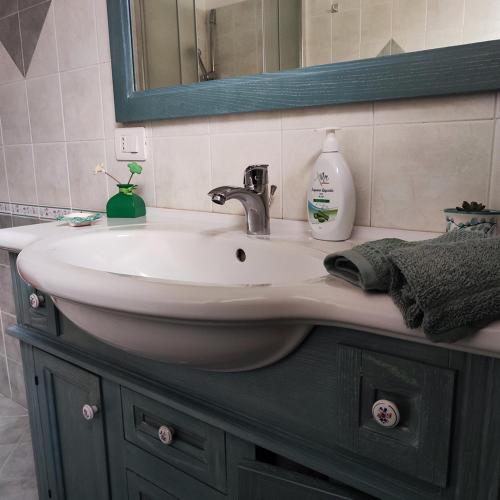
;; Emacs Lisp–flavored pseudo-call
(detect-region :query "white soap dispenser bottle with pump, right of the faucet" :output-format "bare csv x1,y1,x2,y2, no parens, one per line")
307,128,356,241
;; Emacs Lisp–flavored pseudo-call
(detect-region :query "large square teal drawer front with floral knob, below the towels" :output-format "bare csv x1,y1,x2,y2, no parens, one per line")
337,345,455,487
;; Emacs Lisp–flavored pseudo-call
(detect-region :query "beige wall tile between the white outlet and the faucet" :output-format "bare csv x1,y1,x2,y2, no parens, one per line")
153,136,211,211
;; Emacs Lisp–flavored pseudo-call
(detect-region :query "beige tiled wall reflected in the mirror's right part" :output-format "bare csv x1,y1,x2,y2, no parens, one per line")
304,0,500,66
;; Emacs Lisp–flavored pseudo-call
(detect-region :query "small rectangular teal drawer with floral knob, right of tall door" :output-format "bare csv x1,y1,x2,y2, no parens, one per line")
122,388,226,491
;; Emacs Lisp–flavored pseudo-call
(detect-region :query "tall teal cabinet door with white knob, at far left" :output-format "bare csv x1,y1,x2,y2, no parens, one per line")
34,350,109,500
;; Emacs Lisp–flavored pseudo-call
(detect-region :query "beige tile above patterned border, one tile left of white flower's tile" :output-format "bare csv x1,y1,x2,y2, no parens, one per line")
33,142,71,207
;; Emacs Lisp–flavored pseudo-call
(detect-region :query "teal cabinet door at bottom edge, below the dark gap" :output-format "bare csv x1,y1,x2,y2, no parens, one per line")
238,462,371,500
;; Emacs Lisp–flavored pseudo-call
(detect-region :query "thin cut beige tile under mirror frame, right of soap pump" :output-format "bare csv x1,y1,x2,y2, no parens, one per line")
374,92,495,124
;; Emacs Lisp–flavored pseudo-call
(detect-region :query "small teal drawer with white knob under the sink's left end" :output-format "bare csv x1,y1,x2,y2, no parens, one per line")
12,272,59,336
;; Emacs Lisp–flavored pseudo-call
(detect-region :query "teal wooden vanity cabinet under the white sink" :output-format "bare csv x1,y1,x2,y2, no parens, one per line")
6,255,500,500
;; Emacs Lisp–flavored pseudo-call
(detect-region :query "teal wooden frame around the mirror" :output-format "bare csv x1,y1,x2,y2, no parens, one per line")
107,0,500,122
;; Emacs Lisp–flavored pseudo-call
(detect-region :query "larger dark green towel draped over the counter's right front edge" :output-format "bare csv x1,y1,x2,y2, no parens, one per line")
388,236,500,342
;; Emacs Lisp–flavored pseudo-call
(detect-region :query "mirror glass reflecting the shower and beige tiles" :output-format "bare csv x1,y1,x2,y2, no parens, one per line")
130,0,500,90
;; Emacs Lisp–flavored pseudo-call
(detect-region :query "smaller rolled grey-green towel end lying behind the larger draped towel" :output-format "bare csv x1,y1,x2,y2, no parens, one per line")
325,231,484,292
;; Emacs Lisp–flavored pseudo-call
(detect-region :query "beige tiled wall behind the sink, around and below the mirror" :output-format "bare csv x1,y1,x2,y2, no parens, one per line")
0,0,500,406
